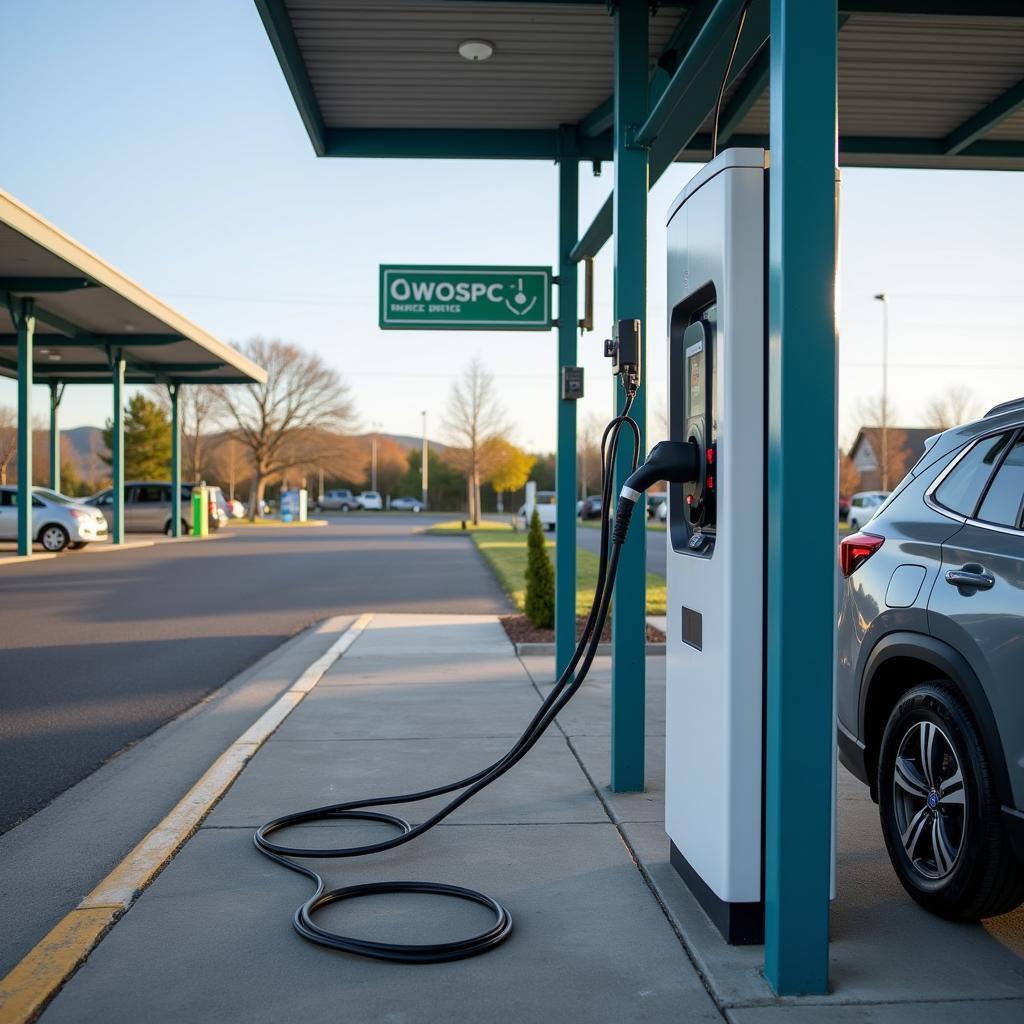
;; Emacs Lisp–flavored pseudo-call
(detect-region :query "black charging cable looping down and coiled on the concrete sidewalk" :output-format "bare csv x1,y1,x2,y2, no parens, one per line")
253,393,640,964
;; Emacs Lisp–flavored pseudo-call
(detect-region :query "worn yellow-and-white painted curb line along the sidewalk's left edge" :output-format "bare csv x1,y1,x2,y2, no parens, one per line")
0,614,374,1024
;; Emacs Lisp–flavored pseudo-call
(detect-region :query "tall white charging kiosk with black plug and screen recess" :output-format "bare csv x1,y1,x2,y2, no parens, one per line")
665,148,767,943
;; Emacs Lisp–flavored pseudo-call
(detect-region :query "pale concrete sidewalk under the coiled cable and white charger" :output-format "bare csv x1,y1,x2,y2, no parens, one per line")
32,615,1024,1024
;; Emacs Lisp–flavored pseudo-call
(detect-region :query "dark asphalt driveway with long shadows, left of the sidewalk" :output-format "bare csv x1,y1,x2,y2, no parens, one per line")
0,514,509,833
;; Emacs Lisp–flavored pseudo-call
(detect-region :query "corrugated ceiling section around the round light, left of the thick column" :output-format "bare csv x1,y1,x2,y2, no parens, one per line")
288,0,681,129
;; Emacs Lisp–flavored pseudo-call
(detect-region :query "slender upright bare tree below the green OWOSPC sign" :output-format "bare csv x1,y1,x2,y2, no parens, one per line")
443,358,508,525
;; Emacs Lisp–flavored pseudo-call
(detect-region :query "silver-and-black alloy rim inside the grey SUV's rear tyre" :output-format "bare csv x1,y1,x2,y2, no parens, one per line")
893,721,967,882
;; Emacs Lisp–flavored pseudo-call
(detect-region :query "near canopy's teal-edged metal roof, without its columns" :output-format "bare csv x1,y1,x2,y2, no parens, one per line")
256,0,1024,169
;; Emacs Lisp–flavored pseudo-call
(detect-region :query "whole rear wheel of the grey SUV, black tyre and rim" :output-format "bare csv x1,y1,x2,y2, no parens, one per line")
878,681,1024,921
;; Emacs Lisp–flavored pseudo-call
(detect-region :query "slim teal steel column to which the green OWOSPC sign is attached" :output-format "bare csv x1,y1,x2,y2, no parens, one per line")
555,140,580,676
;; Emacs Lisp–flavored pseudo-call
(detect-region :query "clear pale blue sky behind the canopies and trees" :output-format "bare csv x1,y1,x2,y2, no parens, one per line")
0,0,1024,449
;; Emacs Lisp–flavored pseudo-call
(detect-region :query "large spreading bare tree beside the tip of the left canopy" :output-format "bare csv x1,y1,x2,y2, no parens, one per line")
215,338,355,519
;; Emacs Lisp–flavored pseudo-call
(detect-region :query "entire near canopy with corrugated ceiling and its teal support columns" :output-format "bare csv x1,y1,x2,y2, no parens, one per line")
249,0,1024,993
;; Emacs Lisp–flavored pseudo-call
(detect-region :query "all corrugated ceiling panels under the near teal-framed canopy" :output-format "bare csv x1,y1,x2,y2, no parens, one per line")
276,0,1024,167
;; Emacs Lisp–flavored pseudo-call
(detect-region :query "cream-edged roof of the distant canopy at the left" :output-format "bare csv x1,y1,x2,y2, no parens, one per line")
0,190,266,384
